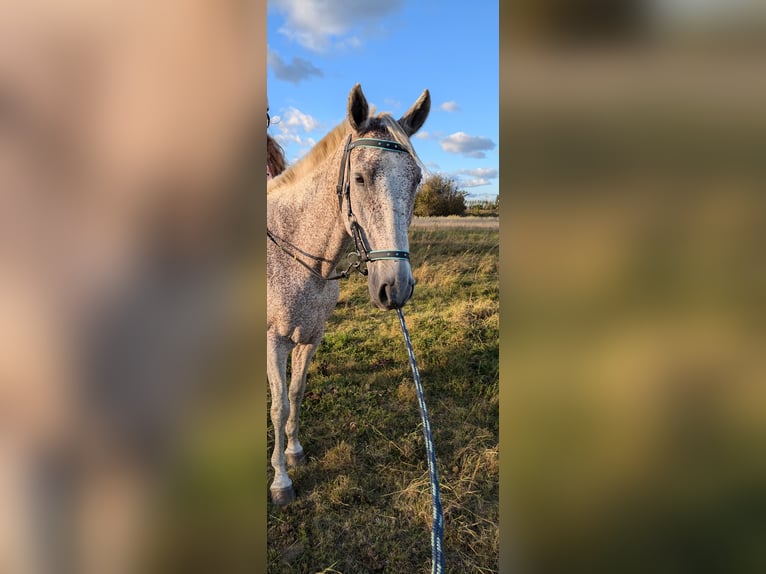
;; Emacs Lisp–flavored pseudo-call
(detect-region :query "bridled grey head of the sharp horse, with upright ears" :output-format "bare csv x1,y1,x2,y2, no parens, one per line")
343,84,431,310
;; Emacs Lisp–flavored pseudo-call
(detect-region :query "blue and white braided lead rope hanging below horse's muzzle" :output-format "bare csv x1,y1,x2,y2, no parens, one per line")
396,309,444,574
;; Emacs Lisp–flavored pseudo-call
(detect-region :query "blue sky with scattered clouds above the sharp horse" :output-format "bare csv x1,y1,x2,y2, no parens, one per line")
267,0,499,199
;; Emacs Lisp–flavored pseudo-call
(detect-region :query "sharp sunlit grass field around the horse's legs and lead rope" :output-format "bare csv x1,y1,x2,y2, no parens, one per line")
263,226,499,573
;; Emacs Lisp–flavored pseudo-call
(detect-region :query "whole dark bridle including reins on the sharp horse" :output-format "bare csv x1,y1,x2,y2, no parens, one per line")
266,135,410,281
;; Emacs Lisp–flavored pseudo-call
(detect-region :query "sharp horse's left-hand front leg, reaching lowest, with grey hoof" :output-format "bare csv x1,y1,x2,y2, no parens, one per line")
266,335,295,505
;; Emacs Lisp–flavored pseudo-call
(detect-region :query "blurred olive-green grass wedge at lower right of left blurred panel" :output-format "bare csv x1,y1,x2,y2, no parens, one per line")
146,268,268,574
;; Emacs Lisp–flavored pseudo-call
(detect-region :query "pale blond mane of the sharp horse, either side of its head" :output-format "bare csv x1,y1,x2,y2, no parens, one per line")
267,110,425,193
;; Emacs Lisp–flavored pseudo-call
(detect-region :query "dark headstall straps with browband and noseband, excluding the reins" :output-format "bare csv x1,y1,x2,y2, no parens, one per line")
335,136,410,275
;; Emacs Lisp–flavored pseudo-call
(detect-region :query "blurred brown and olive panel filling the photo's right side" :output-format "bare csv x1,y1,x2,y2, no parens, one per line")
500,0,766,573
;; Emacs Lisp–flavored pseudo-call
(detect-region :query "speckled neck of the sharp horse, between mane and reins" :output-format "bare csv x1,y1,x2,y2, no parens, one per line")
266,142,351,274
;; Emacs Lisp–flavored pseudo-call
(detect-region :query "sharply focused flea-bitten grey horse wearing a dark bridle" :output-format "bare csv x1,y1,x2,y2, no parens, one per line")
266,84,431,505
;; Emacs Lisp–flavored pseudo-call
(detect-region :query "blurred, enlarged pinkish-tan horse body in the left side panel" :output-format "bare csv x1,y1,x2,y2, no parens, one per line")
0,0,266,574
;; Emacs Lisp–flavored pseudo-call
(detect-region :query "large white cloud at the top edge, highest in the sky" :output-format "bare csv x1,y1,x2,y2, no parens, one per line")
270,0,404,52
